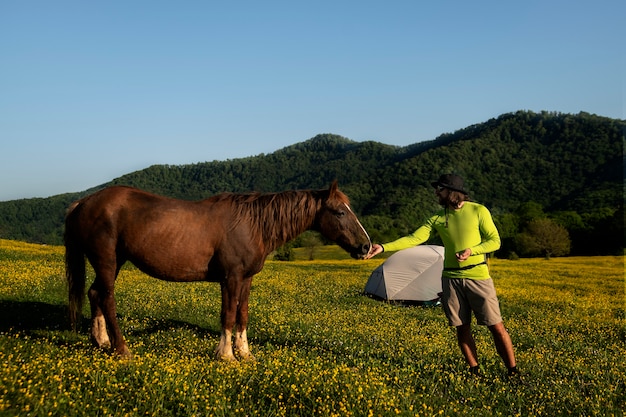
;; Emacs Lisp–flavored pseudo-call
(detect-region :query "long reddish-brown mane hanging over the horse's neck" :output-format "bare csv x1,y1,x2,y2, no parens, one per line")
208,190,350,250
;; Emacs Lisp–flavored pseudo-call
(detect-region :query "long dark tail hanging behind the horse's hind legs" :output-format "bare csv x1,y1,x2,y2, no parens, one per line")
63,202,86,331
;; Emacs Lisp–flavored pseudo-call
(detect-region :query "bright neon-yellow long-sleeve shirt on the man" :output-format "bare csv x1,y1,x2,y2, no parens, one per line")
383,201,500,279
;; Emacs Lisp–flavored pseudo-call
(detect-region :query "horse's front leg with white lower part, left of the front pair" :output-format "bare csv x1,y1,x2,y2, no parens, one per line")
215,276,242,361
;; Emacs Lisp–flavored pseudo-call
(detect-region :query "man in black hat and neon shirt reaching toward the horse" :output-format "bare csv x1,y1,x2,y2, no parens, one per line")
367,174,518,376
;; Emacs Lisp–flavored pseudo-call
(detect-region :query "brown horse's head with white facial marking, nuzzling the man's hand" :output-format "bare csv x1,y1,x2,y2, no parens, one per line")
314,181,372,259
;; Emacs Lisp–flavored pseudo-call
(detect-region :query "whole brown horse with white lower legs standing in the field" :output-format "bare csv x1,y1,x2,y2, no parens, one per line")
65,181,371,360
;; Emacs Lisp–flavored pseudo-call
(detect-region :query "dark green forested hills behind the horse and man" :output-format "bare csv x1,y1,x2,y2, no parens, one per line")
0,111,626,255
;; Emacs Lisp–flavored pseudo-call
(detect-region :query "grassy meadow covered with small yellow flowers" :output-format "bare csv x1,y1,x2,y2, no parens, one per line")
0,240,626,416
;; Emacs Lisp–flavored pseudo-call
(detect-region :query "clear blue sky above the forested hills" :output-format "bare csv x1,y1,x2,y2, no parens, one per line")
0,0,626,201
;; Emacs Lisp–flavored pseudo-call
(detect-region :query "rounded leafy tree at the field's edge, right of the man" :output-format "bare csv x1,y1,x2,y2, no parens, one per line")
517,218,571,259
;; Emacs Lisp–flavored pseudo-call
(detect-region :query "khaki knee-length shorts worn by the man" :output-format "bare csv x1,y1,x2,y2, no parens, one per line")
441,277,502,327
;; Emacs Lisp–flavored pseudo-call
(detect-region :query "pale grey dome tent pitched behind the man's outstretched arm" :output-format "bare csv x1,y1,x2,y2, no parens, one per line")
365,245,443,305
